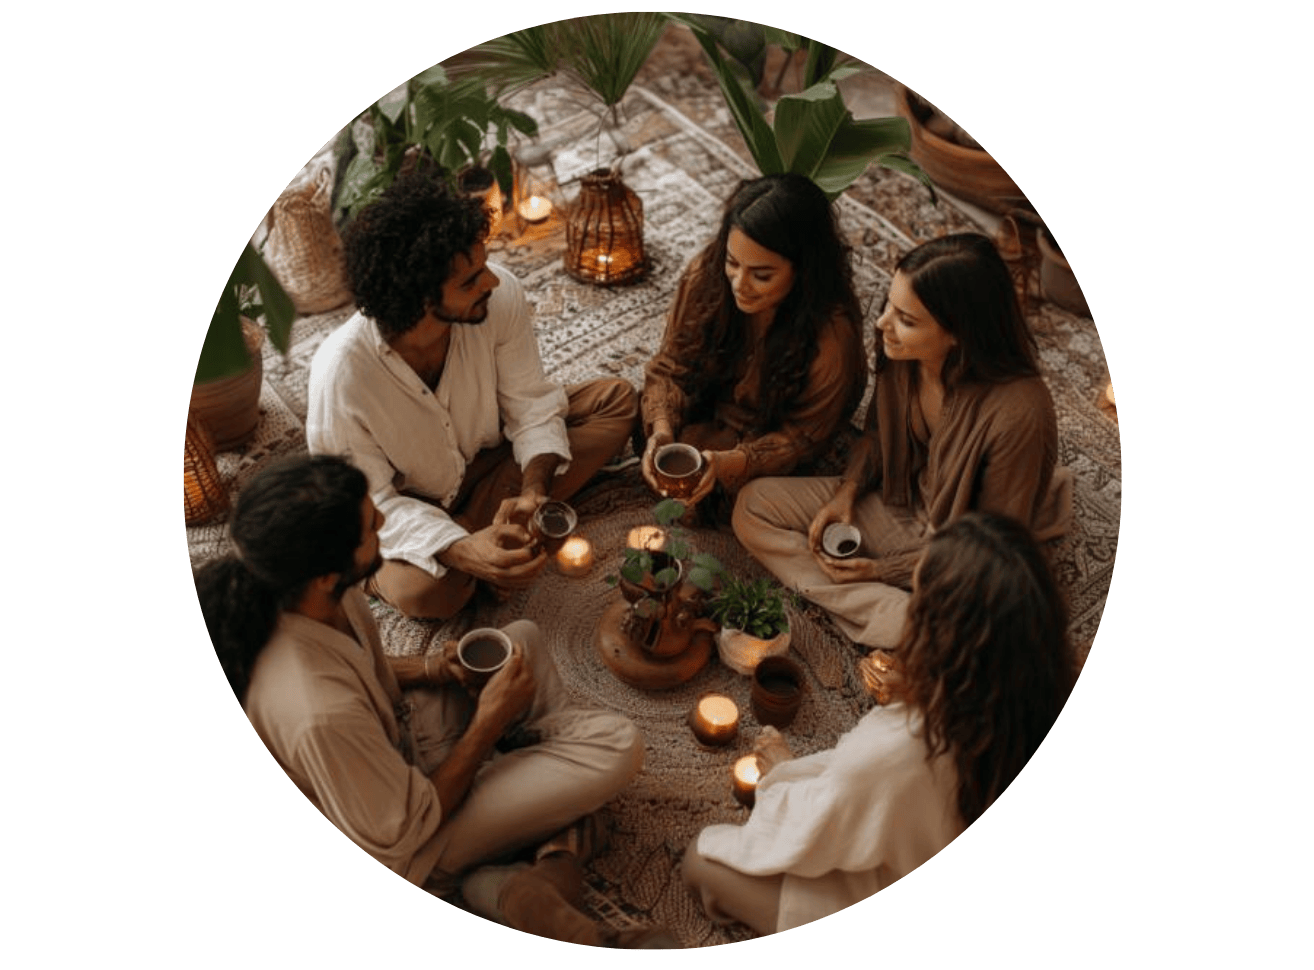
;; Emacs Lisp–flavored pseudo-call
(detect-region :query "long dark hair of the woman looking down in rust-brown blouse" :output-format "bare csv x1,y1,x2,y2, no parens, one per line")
685,173,865,431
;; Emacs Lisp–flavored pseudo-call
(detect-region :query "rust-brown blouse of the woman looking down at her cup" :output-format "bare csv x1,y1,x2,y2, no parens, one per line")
641,266,867,493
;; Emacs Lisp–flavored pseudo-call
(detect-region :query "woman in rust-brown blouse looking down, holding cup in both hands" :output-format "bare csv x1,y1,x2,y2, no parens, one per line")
643,175,867,523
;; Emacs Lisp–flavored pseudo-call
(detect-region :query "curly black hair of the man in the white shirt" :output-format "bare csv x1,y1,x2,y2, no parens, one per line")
343,175,489,340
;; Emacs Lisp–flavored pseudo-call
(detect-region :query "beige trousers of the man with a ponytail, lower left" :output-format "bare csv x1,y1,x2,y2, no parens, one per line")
407,620,644,894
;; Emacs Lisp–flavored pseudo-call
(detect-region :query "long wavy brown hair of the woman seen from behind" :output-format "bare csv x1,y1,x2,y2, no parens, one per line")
899,511,1076,825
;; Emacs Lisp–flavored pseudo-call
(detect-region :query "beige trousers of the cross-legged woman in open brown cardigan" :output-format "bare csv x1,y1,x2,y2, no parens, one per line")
732,477,930,649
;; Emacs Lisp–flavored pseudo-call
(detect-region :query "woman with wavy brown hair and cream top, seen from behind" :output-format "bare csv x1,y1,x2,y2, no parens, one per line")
683,513,1076,935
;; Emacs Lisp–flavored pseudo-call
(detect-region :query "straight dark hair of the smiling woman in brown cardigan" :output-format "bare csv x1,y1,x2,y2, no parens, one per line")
876,233,1038,388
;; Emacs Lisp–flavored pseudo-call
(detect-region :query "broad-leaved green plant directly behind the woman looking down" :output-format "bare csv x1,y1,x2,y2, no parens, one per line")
669,13,936,200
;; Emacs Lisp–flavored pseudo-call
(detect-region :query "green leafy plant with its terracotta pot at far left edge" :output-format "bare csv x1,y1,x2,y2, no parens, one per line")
189,241,297,451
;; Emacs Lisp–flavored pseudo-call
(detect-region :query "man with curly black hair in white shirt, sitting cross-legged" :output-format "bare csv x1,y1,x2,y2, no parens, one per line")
306,176,637,619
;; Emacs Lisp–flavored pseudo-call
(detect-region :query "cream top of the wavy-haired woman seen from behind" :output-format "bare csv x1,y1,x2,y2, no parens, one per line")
698,704,964,933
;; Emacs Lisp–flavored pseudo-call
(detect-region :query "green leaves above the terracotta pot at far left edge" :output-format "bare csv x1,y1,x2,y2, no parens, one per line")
192,241,297,384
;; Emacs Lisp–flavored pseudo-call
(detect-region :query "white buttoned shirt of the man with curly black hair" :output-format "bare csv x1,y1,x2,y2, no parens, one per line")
306,264,570,577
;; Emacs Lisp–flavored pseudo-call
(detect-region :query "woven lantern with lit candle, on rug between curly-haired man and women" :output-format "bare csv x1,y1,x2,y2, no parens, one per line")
565,168,648,287
